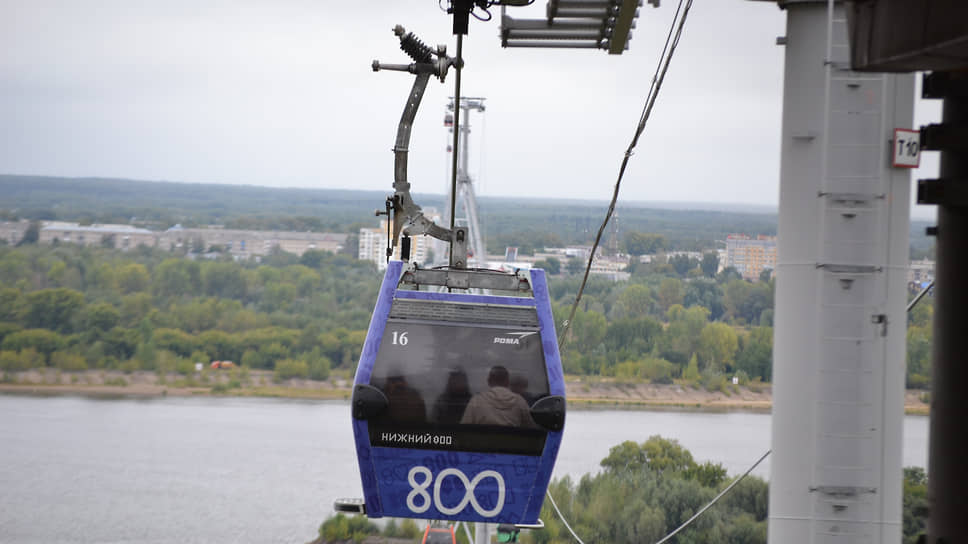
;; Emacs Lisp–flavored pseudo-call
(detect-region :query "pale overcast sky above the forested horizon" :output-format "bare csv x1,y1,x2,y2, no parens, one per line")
0,0,940,216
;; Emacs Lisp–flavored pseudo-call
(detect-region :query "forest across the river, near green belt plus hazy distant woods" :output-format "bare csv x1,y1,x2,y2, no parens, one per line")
0,175,932,389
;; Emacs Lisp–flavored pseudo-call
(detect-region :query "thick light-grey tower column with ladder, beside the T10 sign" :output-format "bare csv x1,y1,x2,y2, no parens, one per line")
768,0,914,544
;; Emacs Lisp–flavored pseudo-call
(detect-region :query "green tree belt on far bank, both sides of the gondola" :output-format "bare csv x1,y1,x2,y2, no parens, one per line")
0,240,932,391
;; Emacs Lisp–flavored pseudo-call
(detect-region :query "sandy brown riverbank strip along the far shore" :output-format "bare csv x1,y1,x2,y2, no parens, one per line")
0,369,929,415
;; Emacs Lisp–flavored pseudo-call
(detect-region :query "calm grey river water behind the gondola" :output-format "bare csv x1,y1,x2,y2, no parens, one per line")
0,395,928,544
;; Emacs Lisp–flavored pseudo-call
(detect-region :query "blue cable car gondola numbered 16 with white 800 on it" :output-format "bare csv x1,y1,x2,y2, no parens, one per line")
344,261,565,525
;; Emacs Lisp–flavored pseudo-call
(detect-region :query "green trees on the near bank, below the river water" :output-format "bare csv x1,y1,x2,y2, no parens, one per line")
318,436,927,544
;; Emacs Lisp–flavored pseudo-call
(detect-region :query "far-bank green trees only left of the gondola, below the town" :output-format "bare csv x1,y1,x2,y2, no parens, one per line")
0,244,379,379
